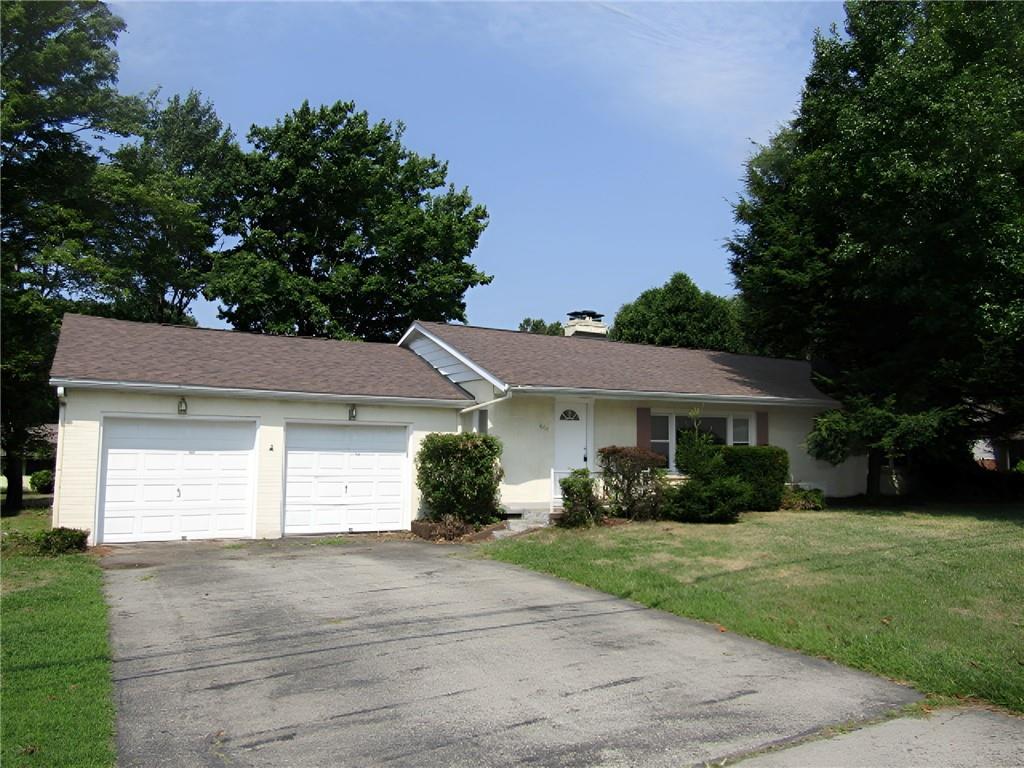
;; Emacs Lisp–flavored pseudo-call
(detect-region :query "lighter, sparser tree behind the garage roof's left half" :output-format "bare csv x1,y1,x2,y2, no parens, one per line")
89,92,242,323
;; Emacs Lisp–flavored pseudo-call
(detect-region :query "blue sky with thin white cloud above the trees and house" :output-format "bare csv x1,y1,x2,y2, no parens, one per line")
112,2,843,328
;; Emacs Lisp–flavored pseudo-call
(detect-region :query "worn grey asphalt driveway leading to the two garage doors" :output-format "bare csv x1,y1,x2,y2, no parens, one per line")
103,539,919,768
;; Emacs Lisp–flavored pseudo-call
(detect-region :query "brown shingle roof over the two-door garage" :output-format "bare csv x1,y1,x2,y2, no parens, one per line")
50,314,472,400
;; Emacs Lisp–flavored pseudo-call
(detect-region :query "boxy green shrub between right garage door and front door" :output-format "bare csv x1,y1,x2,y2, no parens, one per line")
416,432,503,525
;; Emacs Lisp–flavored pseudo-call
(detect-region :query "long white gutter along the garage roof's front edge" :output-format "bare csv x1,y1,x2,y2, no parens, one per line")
50,377,475,409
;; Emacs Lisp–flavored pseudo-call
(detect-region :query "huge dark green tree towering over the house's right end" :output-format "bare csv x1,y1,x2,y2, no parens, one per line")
729,2,1024,490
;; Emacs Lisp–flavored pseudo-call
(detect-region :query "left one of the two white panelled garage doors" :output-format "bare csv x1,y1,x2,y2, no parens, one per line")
99,419,256,543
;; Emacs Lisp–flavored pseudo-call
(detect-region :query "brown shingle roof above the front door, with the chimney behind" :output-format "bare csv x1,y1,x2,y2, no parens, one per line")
420,323,829,401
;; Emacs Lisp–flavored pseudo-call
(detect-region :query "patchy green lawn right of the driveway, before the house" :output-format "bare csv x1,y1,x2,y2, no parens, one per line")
484,507,1024,713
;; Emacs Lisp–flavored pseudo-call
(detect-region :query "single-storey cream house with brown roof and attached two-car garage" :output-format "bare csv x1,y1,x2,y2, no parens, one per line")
51,314,866,543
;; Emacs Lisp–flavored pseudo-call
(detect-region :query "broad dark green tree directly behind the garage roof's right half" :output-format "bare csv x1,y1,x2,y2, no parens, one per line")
206,102,490,341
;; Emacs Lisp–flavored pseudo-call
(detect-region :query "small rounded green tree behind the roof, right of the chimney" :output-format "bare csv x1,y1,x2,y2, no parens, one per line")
610,272,745,352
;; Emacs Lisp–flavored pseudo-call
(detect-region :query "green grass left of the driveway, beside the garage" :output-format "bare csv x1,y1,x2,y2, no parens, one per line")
0,510,114,768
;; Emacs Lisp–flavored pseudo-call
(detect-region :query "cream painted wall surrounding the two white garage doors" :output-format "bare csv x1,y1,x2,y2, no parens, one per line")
53,389,458,539
